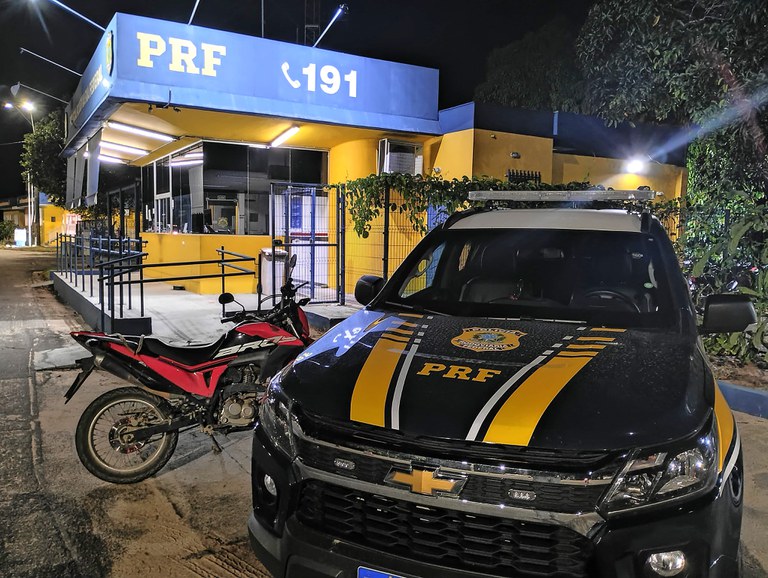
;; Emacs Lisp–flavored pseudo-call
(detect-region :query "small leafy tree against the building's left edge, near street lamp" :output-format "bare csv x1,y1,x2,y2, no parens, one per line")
21,111,67,207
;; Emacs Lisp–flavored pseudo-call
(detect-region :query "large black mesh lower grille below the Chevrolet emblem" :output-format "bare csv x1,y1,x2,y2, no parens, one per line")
296,480,592,578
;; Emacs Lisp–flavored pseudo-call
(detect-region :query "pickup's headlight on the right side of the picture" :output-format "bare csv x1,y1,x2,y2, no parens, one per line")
601,418,718,514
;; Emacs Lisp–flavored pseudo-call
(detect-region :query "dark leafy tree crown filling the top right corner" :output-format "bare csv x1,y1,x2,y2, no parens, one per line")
576,0,768,125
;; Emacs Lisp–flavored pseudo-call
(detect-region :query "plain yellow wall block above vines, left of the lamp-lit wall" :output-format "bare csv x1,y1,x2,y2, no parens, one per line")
474,129,552,183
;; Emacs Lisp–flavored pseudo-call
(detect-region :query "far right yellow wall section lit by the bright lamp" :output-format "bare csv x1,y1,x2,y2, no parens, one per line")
552,153,686,199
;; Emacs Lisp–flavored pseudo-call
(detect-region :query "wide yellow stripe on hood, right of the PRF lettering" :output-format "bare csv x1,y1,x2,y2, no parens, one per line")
483,355,592,446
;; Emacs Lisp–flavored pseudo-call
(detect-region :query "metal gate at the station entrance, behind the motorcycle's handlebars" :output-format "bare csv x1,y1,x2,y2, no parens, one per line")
268,183,344,305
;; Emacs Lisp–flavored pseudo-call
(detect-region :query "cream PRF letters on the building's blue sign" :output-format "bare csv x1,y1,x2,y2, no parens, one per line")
136,32,227,76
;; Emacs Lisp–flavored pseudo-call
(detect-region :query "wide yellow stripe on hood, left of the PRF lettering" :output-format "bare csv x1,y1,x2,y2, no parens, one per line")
349,322,408,427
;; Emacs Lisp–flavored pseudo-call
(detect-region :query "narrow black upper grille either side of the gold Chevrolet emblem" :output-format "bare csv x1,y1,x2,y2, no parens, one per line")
298,440,606,514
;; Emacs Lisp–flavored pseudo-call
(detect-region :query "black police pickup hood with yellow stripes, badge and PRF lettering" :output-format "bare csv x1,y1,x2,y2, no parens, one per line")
282,310,710,450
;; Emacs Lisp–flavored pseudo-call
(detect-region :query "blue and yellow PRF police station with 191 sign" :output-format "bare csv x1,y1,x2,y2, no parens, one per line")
63,14,686,292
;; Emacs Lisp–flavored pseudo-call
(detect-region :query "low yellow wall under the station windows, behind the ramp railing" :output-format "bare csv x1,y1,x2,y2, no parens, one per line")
142,233,272,294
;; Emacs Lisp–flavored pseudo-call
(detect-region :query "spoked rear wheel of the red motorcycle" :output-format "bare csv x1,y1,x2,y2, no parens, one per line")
75,387,179,484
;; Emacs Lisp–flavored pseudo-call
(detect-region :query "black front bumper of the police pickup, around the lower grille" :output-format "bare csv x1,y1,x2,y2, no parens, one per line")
248,420,741,578
